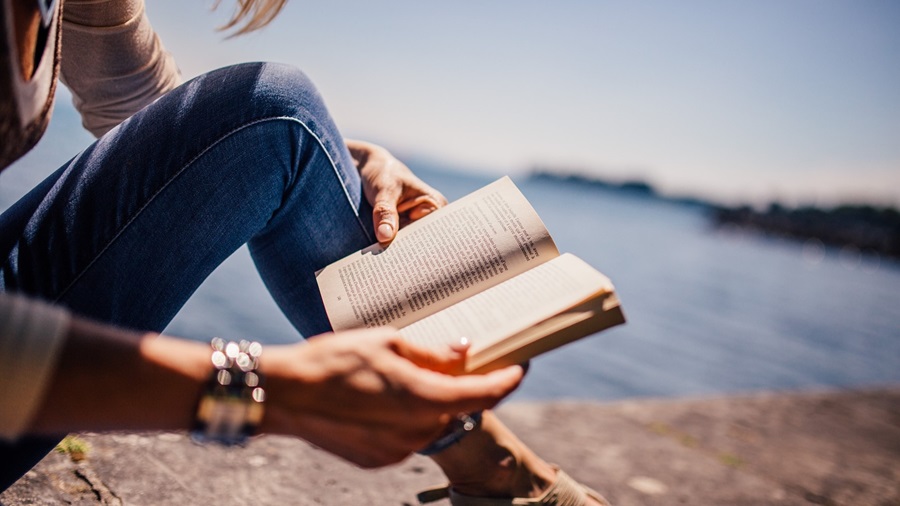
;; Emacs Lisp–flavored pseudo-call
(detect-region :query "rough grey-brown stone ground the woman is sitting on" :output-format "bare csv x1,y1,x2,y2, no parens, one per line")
0,388,900,506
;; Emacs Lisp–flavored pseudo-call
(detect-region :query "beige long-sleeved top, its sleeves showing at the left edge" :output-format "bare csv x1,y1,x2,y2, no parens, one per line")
0,0,181,440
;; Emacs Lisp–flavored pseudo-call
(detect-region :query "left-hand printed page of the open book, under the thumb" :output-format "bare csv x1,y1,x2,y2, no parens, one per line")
316,177,559,330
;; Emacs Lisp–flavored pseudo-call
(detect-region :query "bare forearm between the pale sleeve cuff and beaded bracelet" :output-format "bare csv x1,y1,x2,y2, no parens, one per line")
30,319,212,434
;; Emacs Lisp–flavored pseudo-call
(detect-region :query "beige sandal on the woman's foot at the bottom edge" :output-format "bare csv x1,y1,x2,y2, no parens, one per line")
417,468,610,506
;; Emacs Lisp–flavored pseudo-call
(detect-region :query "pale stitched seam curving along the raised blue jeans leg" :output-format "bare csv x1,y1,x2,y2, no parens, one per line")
53,116,368,302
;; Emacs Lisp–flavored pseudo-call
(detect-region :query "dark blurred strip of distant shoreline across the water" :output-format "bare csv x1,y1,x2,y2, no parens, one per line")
529,169,900,259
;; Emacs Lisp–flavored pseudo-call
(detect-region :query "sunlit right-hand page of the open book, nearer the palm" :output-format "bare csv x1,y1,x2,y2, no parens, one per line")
400,253,613,357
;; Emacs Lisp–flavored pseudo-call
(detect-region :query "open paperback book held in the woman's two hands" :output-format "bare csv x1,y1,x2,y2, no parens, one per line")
316,177,625,373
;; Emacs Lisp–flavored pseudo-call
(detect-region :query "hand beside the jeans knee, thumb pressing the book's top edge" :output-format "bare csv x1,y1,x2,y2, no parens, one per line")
346,140,447,243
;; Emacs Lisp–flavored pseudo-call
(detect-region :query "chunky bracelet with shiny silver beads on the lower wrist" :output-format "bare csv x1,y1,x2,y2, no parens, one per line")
191,337,266,446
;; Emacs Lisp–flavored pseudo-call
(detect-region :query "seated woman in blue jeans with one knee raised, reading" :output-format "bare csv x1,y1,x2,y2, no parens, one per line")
0,0,605,505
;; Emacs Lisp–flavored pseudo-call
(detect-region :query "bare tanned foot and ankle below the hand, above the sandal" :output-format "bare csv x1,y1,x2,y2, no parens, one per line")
432,411,603,506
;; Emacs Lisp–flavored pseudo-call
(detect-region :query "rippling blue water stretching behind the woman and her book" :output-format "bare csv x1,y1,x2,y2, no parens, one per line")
0,108,900,400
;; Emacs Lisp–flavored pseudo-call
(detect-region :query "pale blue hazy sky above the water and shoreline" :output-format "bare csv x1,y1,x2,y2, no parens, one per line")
49,0,900,205
